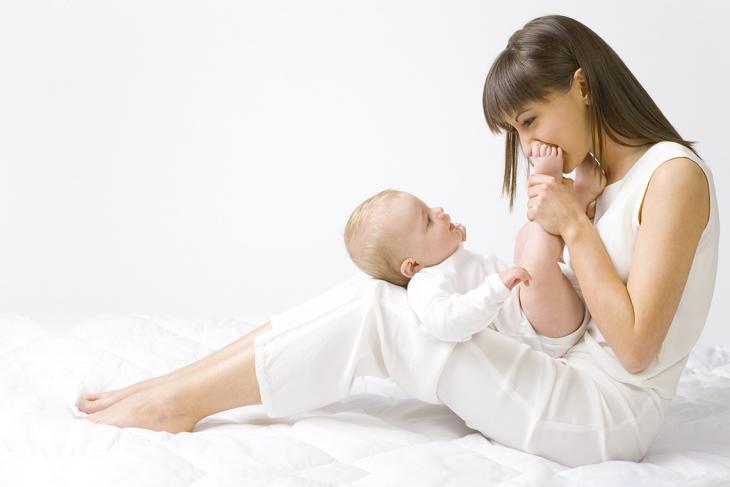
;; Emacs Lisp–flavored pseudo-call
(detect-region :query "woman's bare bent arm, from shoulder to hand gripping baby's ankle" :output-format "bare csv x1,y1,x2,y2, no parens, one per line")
528,158,709,373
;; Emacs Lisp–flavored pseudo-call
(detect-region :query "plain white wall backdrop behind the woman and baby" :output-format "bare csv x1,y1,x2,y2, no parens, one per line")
0,0,730,343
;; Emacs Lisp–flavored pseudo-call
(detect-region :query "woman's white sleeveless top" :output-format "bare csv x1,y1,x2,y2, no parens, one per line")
561,142,720,399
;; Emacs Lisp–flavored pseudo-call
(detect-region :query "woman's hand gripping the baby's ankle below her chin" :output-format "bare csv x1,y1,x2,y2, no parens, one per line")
527,174,585,236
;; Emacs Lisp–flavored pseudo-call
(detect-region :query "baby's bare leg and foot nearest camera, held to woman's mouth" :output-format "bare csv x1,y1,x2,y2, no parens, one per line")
514,143,583,338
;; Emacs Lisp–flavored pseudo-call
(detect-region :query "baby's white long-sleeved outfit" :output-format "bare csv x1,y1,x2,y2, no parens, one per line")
407,243,587,357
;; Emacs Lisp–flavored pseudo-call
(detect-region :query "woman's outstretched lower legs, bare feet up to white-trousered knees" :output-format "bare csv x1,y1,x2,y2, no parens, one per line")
79,273,453,432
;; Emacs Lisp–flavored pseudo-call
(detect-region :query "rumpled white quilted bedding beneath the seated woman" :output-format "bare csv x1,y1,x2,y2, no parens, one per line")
0,315,730,487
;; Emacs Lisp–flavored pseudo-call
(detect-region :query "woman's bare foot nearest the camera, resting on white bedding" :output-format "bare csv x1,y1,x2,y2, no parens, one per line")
77,384,198,433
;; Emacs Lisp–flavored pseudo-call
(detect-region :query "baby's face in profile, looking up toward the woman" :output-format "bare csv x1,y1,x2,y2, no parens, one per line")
389,193,462,277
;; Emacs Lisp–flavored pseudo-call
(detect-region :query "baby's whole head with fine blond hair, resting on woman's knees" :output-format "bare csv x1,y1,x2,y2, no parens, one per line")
344,189,462,287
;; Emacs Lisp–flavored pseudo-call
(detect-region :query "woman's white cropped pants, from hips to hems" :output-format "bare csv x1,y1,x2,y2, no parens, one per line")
254,273,666,466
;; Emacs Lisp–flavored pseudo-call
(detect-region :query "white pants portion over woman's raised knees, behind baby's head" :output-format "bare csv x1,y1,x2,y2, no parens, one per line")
255,273,453,417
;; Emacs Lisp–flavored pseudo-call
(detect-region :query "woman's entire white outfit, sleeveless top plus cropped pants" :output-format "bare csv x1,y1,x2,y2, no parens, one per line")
254,142,720,466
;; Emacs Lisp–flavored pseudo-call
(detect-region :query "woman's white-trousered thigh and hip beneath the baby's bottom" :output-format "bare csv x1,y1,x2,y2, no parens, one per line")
438,329,664,466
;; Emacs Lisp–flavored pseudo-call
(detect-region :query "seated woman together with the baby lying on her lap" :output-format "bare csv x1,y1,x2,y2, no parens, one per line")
77,16,720,466
